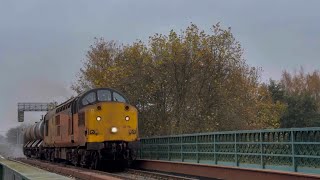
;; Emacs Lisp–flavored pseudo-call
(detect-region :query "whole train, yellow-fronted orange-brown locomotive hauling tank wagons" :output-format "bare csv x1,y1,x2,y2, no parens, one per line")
23,88,138,169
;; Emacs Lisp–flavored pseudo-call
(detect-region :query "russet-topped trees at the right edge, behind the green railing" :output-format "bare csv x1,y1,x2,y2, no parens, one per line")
276,67,320,128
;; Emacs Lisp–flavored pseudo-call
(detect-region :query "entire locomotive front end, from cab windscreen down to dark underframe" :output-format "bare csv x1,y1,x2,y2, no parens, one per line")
77,88,138,166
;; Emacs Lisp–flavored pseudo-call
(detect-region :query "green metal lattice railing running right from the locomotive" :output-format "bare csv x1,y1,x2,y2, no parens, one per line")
139,128,320,173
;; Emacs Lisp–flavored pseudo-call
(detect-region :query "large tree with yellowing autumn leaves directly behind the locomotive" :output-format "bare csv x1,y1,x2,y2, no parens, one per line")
72,24,285,136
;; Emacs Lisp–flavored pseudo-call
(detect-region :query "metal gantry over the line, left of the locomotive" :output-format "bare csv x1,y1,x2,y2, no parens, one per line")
18,102,57,122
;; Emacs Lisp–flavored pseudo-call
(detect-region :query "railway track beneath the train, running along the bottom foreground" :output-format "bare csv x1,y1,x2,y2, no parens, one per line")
14,158,199,180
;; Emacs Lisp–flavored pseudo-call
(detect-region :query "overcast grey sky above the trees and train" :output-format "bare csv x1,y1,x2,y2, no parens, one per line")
0,0,320,133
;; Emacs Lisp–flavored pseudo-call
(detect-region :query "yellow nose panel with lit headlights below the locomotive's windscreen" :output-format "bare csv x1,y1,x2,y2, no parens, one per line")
84,102,138,143
